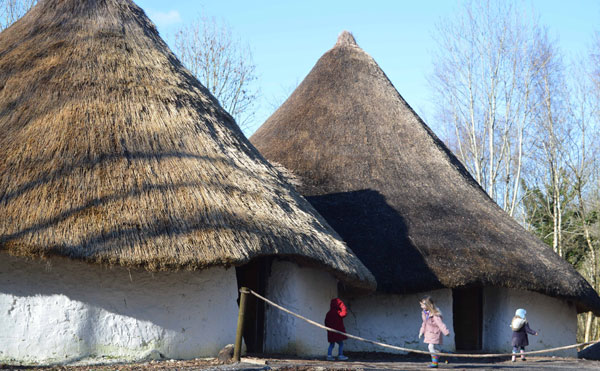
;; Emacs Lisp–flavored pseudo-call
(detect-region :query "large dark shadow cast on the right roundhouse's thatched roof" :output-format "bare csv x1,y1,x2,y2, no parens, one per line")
306,189,443,294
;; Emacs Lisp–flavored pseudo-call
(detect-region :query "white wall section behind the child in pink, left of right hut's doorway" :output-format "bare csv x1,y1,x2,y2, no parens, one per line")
344,289,455,353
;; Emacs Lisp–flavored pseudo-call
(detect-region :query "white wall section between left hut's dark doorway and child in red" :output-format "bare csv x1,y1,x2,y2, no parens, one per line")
264,261,337,356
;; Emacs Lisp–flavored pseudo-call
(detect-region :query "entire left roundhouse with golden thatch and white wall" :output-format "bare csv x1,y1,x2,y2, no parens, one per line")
0,0,375,363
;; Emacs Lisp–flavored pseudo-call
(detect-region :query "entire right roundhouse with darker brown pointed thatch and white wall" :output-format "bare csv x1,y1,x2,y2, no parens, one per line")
250,32,600,354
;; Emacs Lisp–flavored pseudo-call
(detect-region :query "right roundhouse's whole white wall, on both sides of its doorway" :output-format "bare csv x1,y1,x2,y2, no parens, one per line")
344,288,577,357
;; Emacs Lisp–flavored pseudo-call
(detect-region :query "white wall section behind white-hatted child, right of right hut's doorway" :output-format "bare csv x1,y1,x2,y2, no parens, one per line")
483,287,577,357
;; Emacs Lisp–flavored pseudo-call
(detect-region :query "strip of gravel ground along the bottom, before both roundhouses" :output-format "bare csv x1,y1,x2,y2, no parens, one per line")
0,354,600,371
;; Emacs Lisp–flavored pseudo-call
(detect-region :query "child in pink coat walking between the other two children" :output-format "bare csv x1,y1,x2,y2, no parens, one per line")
419,296,450,368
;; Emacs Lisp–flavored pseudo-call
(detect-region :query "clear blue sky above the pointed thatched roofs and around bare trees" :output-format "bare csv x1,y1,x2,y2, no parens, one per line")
135,0,600,136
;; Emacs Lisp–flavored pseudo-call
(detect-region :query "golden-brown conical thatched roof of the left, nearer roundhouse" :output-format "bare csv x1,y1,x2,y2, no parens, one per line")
0,0,374,288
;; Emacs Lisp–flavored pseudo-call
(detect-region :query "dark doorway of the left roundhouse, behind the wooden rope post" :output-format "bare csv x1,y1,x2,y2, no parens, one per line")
235,257,271,353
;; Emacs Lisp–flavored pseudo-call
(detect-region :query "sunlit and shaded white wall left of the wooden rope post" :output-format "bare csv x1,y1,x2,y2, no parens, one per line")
0,253,238,364
